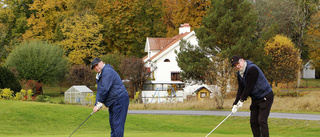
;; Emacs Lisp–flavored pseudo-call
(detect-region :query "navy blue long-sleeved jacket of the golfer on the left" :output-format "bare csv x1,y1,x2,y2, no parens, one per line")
96,64,128,107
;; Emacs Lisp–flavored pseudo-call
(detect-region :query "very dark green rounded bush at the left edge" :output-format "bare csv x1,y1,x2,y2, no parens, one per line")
0,67,21,94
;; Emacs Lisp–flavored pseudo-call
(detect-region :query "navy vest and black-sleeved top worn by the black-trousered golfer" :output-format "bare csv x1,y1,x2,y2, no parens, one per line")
234,60,272,104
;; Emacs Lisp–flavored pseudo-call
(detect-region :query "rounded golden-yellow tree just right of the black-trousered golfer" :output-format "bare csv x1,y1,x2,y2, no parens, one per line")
265,35,301,85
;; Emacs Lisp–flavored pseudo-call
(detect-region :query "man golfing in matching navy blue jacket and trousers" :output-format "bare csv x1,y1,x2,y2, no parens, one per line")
91,58,129,137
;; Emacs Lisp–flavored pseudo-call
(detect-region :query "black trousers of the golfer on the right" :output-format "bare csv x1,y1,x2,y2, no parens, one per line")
250,92,273,137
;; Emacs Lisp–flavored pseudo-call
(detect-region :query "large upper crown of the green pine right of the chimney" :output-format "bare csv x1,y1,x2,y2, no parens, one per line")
195,0,257,59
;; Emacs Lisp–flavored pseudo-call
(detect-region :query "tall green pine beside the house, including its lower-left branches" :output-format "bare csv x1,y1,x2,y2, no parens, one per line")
177,0,263,81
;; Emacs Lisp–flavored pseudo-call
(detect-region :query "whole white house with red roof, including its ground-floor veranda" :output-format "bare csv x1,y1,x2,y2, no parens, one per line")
142,23,209,103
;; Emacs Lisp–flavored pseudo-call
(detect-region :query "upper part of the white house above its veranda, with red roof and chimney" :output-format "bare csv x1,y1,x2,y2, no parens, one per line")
143,23,198,82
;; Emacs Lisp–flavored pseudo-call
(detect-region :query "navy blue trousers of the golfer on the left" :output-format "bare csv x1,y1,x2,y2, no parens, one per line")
109,96,129,137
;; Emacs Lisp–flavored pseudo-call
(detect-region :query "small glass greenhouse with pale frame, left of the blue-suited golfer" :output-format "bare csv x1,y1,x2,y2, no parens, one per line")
64,85,93,105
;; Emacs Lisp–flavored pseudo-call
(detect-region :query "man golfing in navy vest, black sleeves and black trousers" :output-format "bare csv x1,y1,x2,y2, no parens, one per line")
231,55,273,137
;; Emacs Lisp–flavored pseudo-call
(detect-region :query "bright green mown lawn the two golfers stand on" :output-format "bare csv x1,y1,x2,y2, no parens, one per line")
0,100,320,137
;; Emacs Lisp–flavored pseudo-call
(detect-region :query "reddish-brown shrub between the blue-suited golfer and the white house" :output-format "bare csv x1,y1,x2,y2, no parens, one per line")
120,57,150,102
